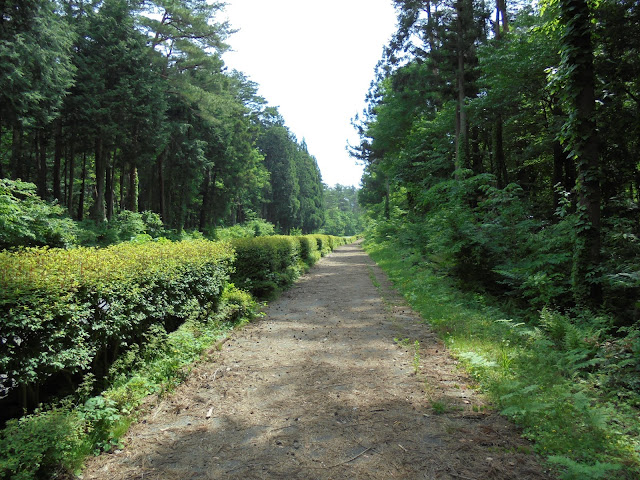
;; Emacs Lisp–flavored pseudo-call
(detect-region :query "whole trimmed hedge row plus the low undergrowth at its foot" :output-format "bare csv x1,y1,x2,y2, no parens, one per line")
0,235,356,480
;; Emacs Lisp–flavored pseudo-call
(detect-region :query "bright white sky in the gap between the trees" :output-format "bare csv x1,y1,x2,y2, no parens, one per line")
223,0,396,187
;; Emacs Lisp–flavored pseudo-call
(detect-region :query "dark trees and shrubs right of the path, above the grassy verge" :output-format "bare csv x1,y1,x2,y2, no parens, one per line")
353,0,640,326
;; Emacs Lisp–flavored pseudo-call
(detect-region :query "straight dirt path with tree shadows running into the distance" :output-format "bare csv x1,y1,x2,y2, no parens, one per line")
83,244,549,480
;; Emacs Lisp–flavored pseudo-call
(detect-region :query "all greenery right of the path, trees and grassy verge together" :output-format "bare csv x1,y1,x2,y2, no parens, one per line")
352,0,640,479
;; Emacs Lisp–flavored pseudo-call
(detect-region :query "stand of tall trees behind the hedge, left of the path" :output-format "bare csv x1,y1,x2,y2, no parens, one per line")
0,0,323,237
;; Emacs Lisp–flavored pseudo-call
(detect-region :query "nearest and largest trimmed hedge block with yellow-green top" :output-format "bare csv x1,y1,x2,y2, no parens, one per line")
0,240,234,407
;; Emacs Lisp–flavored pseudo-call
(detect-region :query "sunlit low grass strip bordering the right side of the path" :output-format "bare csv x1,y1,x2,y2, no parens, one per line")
365,236,640,480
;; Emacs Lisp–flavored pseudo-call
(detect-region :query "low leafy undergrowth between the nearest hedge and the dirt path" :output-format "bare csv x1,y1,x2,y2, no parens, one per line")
0,284,257,480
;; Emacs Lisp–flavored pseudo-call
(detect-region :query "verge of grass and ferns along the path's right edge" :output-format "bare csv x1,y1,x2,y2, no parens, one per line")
366,231,640,479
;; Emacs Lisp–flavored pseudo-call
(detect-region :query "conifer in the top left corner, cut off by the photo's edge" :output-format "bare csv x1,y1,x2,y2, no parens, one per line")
0,0,74,191
